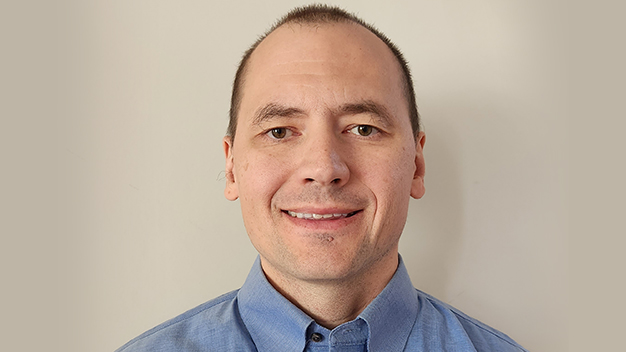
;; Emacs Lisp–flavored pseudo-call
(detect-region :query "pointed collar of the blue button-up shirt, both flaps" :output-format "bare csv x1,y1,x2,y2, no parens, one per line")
238,256,418,352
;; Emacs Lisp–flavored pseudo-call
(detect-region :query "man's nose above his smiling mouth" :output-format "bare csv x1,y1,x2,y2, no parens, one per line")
298,133,350,187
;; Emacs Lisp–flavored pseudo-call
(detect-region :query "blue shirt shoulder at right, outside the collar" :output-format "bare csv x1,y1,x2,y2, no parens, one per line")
412,290,526,352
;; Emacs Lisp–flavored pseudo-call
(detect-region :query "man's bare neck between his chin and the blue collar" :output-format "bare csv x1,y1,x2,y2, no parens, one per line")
261,252,398,330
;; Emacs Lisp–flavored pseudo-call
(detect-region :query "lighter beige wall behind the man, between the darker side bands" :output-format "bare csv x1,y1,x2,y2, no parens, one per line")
54,0,568,352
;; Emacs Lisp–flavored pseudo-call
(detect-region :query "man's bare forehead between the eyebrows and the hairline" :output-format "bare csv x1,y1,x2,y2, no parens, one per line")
240,23,406,121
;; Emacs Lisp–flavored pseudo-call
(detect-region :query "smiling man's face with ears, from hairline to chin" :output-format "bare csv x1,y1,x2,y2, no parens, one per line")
224,24,424,280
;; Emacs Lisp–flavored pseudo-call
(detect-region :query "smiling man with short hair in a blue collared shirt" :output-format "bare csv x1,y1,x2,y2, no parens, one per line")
118,5,524,352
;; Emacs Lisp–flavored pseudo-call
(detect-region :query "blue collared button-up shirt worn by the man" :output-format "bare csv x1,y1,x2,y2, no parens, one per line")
117,258,526,352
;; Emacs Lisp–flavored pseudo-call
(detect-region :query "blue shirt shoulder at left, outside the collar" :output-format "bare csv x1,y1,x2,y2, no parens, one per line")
116,290,252,352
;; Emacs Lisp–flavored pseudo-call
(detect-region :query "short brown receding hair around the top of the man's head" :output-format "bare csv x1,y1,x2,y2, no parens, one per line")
226,4,420,140
